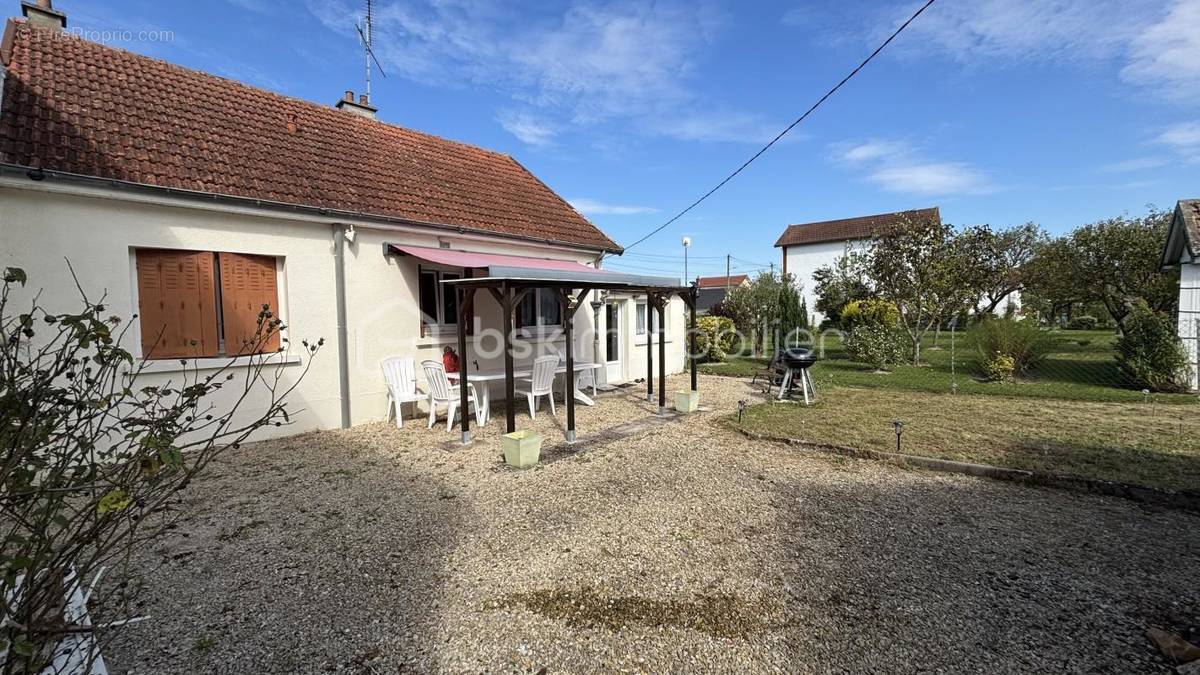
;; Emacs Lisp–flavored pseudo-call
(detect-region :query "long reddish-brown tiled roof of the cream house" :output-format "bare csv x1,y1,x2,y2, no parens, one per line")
0,19,619,250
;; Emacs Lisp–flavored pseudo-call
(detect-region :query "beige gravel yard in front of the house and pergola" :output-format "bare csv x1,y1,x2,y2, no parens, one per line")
98,377,1200,674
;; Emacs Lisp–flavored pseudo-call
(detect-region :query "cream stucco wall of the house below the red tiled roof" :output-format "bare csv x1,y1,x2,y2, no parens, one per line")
0,179,684,435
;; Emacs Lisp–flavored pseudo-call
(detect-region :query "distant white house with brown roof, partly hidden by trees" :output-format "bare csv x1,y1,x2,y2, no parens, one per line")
775,207,942,325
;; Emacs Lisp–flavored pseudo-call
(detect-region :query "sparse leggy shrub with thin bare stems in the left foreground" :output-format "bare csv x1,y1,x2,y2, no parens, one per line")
0,268,320,674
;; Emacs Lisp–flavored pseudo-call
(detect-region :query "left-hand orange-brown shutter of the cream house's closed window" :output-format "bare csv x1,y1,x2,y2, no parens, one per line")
137,249,217,359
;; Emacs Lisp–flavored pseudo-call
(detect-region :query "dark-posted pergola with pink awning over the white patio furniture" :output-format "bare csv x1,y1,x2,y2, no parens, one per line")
384,244,696,444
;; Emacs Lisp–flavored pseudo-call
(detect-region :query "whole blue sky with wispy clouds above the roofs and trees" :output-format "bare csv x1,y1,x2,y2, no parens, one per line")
56,0,1200,275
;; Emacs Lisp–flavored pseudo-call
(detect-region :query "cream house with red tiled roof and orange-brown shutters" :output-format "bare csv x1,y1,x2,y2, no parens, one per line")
0,2,685,432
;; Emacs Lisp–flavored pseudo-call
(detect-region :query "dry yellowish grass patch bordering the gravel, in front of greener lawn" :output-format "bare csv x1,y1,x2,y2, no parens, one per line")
742,386,1200,490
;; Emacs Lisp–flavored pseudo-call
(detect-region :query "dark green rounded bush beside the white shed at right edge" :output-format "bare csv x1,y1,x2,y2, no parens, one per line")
1116,301,1188,392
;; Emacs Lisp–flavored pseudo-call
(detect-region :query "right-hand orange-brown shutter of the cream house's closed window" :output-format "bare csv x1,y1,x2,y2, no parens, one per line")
218,253,280,356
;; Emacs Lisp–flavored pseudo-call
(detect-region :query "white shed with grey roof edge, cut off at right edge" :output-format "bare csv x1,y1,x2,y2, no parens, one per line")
1162,199,1200,389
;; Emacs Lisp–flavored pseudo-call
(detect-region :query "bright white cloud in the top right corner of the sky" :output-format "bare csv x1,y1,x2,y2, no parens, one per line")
1121,0,1200,102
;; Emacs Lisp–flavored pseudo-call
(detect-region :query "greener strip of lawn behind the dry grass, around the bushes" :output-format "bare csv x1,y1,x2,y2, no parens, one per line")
700,330,1200,405
